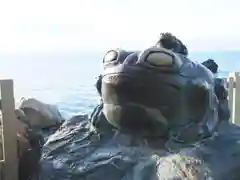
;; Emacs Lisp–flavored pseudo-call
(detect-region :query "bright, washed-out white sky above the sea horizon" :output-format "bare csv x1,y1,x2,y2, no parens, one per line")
0,0,240,53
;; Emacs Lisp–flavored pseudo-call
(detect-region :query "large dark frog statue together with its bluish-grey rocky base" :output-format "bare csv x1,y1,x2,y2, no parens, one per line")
39,47,240,180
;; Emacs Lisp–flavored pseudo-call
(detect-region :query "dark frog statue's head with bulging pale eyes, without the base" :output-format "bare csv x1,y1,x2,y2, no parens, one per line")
97,47,218,141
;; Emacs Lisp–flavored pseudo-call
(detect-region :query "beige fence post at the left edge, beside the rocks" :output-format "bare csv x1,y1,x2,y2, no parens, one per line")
0,80,18,180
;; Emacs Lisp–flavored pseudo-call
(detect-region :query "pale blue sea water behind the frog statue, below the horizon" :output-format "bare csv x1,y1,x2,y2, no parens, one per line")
0,50,236,118
